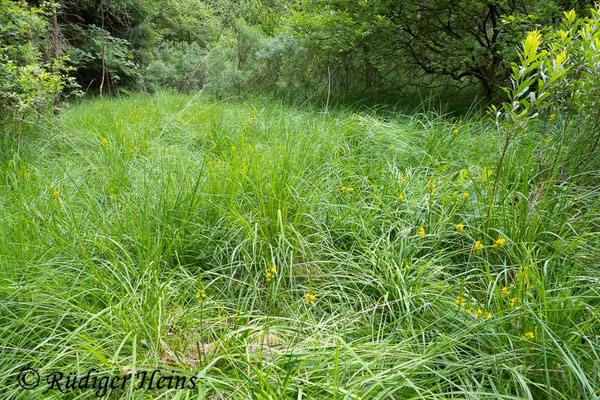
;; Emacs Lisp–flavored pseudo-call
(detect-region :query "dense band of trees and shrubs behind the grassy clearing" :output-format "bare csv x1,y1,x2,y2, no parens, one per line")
0,0,593,112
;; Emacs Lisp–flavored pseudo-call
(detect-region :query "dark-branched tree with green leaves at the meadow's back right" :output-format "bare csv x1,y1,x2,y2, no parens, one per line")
382,0,583,98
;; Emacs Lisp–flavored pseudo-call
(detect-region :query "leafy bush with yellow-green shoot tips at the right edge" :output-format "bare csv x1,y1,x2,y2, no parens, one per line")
494,4,600,174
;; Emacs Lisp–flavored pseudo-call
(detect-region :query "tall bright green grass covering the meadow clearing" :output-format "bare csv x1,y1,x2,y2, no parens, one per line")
0,94,600,399
